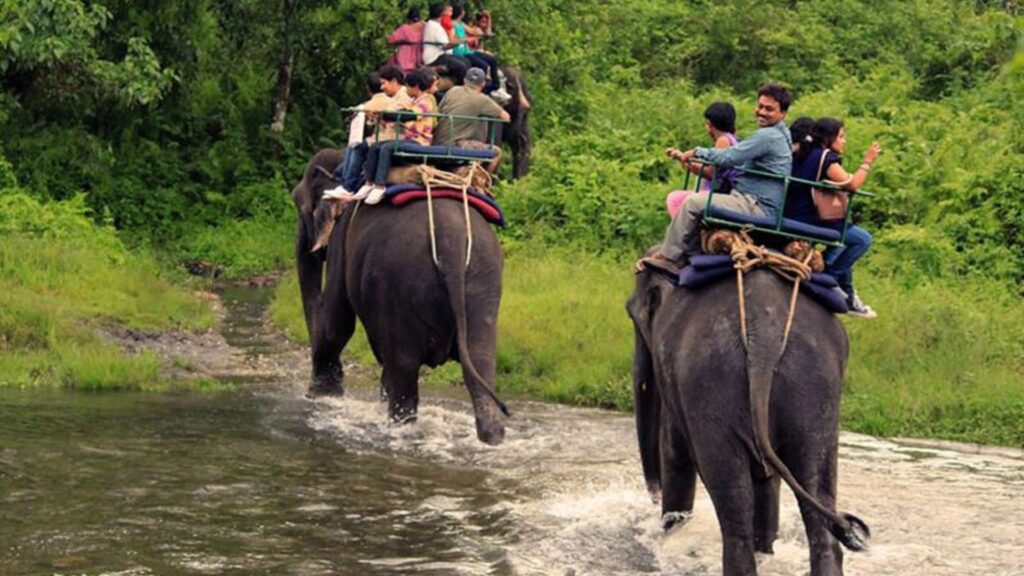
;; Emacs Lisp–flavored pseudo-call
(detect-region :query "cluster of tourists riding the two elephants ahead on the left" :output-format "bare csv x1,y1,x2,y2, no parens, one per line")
324,3,520,204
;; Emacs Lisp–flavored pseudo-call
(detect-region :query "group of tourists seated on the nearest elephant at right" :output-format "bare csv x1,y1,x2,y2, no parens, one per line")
641,84,882,318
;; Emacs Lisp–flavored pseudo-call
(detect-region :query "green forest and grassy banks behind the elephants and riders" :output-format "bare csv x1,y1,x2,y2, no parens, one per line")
0,0,1024,446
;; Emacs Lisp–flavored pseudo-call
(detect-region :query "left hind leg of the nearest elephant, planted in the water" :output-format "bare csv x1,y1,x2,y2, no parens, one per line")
700,450,757,576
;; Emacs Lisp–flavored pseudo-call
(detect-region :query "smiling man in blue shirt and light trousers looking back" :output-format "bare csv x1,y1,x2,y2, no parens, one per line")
642,84,793,274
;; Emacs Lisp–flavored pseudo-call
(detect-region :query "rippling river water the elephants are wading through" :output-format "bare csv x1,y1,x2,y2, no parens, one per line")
0,284,1024,576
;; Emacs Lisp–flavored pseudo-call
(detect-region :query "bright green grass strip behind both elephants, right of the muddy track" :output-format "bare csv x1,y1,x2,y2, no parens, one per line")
271,245,1024,446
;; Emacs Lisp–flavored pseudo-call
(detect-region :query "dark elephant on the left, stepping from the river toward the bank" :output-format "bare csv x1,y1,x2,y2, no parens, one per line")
292,150,509,445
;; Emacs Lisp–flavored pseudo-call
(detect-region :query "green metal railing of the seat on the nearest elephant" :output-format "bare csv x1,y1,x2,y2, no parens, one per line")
683,158,874,246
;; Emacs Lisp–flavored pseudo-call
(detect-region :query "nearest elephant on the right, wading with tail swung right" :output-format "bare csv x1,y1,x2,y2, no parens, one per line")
627,269,870,576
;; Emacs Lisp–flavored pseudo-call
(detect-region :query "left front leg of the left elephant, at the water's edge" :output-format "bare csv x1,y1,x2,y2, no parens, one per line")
307,235,355,397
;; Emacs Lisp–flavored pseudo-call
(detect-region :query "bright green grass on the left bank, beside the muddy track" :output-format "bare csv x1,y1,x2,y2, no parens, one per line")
0,191,214,389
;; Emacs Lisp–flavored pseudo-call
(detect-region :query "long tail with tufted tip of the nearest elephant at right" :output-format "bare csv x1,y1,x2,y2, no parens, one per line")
746,331,871,551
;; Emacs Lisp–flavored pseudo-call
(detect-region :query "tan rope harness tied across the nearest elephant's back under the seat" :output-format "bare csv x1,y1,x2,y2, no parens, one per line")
701,230,816,351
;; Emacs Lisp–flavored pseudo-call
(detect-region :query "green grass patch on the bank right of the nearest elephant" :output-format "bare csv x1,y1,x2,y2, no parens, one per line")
844,276,1024,446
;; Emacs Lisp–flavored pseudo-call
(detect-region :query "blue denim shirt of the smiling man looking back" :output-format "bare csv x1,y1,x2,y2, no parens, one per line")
696,122,793,216
